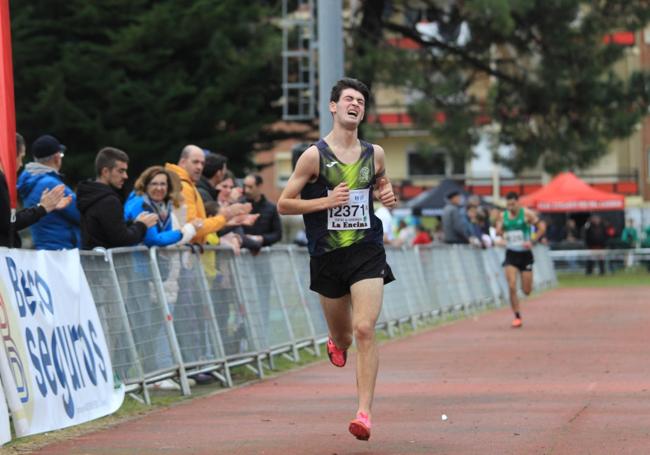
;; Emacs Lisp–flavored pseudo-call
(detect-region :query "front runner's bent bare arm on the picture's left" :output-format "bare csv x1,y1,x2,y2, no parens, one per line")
278,145,349,215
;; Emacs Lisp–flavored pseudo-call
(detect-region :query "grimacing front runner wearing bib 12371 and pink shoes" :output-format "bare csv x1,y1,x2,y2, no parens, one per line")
278,78,396,440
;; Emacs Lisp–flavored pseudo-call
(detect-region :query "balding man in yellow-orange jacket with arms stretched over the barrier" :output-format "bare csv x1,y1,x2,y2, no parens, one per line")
165,145,252,244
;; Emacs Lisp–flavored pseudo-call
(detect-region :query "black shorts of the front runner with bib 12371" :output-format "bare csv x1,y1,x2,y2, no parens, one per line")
309,243,395,299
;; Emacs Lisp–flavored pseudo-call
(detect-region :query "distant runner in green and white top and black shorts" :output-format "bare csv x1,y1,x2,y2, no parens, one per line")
497,191,546,328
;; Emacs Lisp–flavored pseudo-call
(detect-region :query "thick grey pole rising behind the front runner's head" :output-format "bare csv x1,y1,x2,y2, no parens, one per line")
318,0,343,137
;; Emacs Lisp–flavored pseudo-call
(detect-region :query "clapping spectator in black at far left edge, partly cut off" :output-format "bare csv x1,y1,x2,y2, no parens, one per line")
0,134,72,248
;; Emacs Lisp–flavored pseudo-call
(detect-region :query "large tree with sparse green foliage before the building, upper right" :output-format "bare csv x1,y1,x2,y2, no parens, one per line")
350,0,650,173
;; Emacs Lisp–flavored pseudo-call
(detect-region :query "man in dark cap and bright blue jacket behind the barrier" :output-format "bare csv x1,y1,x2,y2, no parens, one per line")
18,134,81,250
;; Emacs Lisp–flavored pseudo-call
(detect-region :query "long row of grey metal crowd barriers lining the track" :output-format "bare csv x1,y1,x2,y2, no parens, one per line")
81,245,557,402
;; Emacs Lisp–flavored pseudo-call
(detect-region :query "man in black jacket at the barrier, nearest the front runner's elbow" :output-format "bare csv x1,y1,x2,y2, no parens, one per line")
244,174,282,250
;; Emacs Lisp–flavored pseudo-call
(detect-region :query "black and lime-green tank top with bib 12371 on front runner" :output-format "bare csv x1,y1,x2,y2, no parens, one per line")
300,139,383,256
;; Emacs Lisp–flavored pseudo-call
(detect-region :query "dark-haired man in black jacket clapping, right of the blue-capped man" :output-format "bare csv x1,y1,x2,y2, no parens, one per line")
77,147,158,250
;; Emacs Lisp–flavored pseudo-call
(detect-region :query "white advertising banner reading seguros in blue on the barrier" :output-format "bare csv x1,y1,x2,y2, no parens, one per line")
0,248,124,437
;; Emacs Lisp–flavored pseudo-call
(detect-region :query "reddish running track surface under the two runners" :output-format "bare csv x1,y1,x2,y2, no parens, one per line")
34,287,650,455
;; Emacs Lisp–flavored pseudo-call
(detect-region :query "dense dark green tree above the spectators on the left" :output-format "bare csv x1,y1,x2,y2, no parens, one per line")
11,0,281,185
